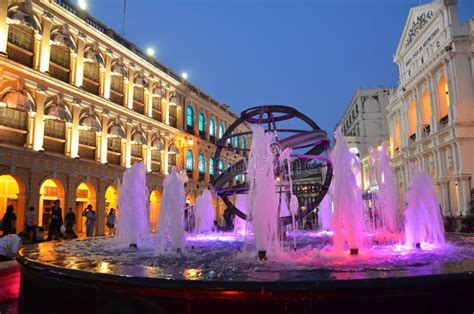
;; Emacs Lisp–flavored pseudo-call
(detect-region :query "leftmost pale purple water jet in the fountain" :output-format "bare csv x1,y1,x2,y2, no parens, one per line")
116,162,150,247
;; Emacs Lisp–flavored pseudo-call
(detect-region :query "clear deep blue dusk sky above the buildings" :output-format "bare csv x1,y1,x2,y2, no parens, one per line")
83,0,474,132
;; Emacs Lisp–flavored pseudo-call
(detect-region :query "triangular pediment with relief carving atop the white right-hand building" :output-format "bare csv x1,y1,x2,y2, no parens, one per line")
395,3,442,56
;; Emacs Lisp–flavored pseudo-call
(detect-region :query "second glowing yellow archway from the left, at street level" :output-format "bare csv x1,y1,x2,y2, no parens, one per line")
38,179,64,231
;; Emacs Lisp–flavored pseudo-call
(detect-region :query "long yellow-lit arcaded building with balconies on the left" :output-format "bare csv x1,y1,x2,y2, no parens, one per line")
0,0,248,234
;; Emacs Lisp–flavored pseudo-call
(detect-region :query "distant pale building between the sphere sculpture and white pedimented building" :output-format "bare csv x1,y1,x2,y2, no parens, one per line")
336,88,393,157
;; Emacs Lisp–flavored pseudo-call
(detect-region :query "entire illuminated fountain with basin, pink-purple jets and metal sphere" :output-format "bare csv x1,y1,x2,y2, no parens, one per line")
14,106,474,313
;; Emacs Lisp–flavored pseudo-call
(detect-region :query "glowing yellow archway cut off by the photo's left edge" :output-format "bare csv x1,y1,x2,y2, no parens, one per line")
0,174,26,232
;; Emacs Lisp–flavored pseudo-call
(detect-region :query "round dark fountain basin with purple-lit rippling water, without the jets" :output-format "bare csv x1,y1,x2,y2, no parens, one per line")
18,233,474,313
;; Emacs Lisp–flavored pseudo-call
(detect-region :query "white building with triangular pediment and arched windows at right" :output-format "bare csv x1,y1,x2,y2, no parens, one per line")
388,0,474,216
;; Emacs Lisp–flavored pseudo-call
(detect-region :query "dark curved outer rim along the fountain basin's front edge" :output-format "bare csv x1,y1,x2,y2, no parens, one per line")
17,238,474,297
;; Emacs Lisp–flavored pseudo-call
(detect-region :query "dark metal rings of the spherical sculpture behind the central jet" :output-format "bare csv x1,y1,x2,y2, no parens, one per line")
212,105,333,225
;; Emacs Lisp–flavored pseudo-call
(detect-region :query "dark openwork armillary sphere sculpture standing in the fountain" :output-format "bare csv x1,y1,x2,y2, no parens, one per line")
212,105,333,225
